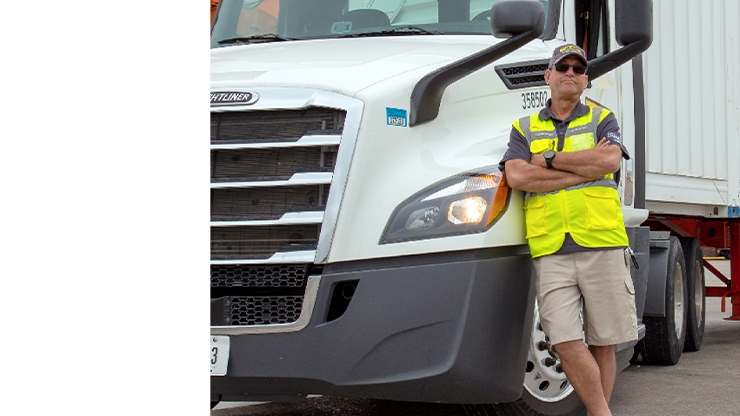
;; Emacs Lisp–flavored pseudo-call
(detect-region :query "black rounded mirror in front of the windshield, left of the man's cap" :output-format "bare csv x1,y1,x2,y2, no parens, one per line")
491,0,545,38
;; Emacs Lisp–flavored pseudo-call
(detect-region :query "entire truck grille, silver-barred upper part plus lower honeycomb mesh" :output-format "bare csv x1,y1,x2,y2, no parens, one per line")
211,98,346,326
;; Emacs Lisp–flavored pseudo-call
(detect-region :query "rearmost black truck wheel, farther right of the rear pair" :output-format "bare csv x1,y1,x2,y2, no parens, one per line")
681,238,706,351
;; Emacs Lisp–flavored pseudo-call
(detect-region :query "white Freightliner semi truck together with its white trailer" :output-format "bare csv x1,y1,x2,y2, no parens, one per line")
211,0,740,415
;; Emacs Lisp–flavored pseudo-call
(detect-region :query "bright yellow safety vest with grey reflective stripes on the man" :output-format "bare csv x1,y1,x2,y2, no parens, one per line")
514,107,629,258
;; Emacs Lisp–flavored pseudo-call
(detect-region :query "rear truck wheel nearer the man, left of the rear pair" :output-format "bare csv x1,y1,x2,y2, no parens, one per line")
643,237,688,365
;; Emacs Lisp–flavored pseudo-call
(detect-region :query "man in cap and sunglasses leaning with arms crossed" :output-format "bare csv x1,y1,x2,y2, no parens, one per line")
501,45,637,416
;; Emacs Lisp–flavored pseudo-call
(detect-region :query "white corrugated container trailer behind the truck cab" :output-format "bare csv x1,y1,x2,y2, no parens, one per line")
643,0,740,218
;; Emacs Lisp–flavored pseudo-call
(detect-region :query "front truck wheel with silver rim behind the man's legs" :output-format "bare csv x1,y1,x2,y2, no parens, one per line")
464,303,586,416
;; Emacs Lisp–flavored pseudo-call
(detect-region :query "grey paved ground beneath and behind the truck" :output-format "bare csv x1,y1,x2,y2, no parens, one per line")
211,260,740,416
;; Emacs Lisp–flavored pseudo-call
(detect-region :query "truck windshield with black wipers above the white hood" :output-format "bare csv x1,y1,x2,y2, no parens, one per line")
211,0,560,48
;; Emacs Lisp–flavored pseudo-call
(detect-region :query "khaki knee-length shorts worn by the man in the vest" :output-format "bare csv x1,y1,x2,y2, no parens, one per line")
534,249,637,345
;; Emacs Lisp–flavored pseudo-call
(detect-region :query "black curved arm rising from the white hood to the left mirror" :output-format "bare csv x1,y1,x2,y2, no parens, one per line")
409,13,545,127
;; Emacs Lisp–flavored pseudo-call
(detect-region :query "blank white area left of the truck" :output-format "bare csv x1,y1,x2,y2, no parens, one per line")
0,0,210,416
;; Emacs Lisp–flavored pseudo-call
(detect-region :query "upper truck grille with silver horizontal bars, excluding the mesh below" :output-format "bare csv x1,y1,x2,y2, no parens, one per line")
211,107,345,260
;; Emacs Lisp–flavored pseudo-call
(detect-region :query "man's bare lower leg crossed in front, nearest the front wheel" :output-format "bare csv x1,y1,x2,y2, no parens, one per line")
554,340,613,416
